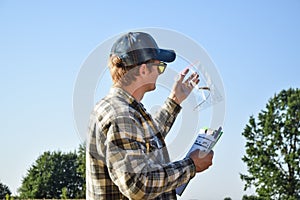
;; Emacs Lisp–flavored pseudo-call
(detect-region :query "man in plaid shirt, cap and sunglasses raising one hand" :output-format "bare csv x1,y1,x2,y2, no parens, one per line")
86,32,213,200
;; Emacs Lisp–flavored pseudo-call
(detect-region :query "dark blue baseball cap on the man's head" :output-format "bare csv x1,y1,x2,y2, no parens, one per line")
110,32,176,66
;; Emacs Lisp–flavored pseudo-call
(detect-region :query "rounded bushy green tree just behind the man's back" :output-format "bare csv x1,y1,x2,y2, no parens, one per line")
19,147,85,199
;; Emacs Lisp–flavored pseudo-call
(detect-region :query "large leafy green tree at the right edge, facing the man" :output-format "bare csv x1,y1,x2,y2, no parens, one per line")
240,88,300,200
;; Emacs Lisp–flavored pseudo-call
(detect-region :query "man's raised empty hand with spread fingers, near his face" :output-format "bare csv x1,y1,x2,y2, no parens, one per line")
169,68,200,104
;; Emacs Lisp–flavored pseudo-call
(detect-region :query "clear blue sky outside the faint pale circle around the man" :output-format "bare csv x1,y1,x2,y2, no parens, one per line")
0,0,300,199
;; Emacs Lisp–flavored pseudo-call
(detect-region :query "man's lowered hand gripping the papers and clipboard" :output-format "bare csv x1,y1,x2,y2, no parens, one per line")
190,149,214,172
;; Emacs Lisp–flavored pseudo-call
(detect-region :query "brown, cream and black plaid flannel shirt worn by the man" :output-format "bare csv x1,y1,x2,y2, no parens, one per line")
86,88,196,200
